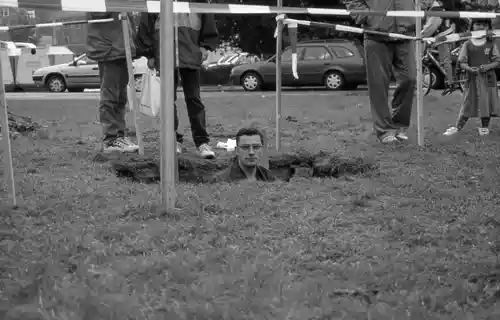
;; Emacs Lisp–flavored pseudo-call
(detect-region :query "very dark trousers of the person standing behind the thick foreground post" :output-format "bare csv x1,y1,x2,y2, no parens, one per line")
174,68,210,147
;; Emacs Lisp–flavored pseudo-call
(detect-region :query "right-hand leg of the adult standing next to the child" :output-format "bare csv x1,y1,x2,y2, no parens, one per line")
391,41,417,140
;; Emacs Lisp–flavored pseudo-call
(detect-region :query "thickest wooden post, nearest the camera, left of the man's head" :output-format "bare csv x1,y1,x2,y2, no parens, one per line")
160,0,177,211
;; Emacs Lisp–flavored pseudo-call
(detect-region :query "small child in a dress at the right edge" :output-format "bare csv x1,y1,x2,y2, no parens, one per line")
444,20,500,136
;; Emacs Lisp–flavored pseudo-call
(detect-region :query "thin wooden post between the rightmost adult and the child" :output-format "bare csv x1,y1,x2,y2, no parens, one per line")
415,0,425,147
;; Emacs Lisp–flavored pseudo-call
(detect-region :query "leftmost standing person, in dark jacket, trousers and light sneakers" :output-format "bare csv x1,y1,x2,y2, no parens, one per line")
86,12,139,152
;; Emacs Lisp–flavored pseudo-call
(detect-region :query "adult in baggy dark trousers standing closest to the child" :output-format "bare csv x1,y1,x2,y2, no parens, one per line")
344,0,417,144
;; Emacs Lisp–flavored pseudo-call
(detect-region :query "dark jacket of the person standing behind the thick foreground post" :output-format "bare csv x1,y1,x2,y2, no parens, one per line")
135,13,219,69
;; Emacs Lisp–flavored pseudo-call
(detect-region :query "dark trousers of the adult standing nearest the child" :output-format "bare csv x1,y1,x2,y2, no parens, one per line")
365,38,416,137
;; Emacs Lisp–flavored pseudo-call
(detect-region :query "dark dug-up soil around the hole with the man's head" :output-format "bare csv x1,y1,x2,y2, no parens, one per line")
99,152,376,183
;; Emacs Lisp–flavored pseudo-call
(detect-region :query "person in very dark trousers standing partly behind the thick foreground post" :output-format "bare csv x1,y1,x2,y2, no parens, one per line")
136,6,219,159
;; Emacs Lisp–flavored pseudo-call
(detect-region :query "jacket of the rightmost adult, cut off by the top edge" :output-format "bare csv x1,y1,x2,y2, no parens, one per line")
344,0,415,34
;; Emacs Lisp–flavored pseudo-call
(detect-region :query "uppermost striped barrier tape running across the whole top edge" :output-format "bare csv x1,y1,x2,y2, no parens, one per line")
0,0,500,19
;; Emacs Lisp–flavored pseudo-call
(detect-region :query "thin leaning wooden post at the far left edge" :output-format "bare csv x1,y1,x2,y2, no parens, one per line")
0,51,17,206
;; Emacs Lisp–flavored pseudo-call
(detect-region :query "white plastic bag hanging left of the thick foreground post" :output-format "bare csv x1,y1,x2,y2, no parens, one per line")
139,71,161,118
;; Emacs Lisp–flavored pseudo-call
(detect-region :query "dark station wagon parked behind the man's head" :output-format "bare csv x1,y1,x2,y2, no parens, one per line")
230,39,366,91
